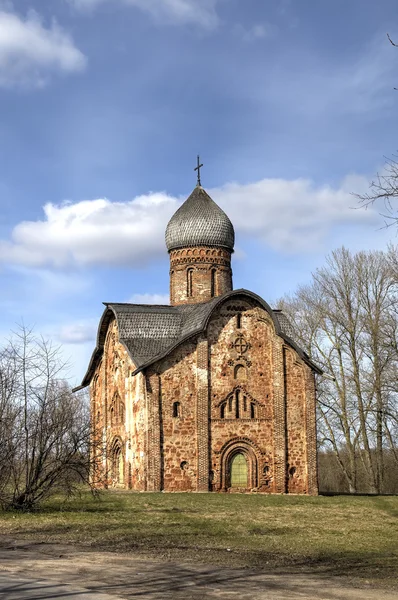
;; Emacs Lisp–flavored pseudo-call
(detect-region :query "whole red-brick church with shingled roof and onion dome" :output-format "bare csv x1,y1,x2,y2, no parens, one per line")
77,169,320,494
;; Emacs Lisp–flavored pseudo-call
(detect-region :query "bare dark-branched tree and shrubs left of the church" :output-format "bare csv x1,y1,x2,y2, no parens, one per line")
0,326,97,509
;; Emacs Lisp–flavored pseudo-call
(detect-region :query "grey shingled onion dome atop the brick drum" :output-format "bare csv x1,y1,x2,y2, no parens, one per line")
166,185,235,251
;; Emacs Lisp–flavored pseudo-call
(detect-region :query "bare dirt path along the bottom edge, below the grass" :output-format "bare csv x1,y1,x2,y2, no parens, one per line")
0,538,398,600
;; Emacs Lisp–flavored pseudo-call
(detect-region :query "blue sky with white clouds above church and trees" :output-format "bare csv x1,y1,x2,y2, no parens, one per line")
0,0,398,383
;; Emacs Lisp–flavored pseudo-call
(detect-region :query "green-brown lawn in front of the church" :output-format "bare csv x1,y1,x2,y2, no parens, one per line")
0,491,398,587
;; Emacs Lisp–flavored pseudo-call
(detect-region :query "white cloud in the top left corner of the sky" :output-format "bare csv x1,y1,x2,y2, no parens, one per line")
0,7,87,88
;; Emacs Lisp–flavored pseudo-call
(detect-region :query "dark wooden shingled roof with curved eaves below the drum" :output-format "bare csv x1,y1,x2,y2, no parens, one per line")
76,289,321,389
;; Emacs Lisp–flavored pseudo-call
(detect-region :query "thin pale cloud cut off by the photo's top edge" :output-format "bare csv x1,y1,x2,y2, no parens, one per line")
69,0,218,29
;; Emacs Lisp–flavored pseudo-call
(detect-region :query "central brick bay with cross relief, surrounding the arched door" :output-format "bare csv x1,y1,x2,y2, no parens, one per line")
208,297,274,491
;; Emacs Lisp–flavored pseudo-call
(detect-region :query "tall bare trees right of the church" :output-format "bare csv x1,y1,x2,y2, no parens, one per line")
281,248,398,492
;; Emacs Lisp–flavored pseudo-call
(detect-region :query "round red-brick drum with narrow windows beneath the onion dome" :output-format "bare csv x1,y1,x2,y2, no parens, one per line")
170,246,232,305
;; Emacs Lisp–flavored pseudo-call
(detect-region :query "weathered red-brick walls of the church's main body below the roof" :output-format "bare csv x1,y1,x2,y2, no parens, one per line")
91,296,317,494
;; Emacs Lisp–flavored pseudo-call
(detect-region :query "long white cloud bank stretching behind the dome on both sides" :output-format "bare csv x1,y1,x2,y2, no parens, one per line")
0,176,380,268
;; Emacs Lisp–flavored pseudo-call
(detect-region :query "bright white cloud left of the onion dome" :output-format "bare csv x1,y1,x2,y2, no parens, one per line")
0,193,177,268
